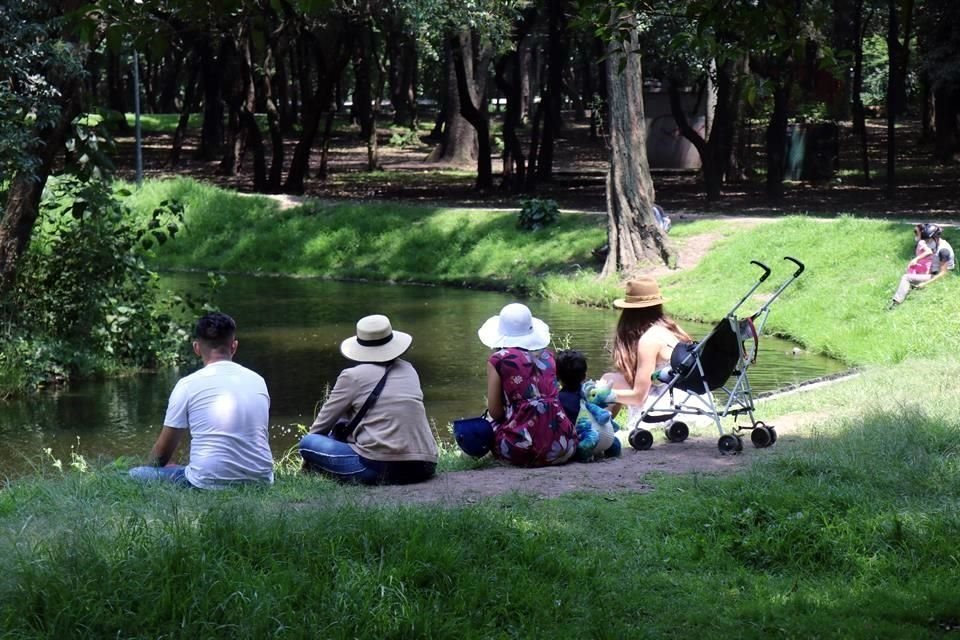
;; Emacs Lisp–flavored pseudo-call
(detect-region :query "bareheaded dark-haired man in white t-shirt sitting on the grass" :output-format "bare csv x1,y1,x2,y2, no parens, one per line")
130,312,273,489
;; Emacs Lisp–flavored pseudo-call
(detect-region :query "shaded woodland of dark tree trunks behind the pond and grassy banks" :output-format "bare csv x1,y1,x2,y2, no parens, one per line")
0,0,960,282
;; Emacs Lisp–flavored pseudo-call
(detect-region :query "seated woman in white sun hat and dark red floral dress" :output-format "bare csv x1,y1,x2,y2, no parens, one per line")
477,303,577,467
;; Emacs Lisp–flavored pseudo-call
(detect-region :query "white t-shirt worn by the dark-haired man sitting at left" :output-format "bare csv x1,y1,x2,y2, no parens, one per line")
163,360,273,489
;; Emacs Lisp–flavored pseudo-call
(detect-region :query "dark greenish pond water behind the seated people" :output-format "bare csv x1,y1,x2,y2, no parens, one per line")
0,274,843,475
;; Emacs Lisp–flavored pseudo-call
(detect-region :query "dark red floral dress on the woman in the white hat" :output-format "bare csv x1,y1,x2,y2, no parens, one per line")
489,347,577,467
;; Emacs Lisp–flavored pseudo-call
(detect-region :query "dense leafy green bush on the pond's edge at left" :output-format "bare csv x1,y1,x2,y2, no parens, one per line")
6,175,187,378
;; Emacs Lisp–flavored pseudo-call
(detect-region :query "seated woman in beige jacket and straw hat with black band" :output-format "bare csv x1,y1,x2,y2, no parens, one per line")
300,315,437,484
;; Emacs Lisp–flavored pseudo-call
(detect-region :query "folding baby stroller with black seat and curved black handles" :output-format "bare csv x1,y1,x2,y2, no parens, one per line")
629,256,804,454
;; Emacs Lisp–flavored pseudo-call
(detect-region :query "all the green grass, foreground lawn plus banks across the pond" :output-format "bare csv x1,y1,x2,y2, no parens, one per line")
0,181,960,640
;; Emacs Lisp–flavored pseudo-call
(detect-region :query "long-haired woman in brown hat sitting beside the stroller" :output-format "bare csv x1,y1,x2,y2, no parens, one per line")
603,276,691,424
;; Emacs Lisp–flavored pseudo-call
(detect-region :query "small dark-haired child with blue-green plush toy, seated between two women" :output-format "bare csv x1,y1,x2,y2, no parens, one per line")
557,350,622,462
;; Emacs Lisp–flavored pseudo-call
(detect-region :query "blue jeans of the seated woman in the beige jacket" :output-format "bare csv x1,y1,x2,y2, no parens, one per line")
300,433,437,484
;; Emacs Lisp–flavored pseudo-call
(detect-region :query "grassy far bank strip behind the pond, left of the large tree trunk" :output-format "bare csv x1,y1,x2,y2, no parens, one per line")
125,180,604,290
